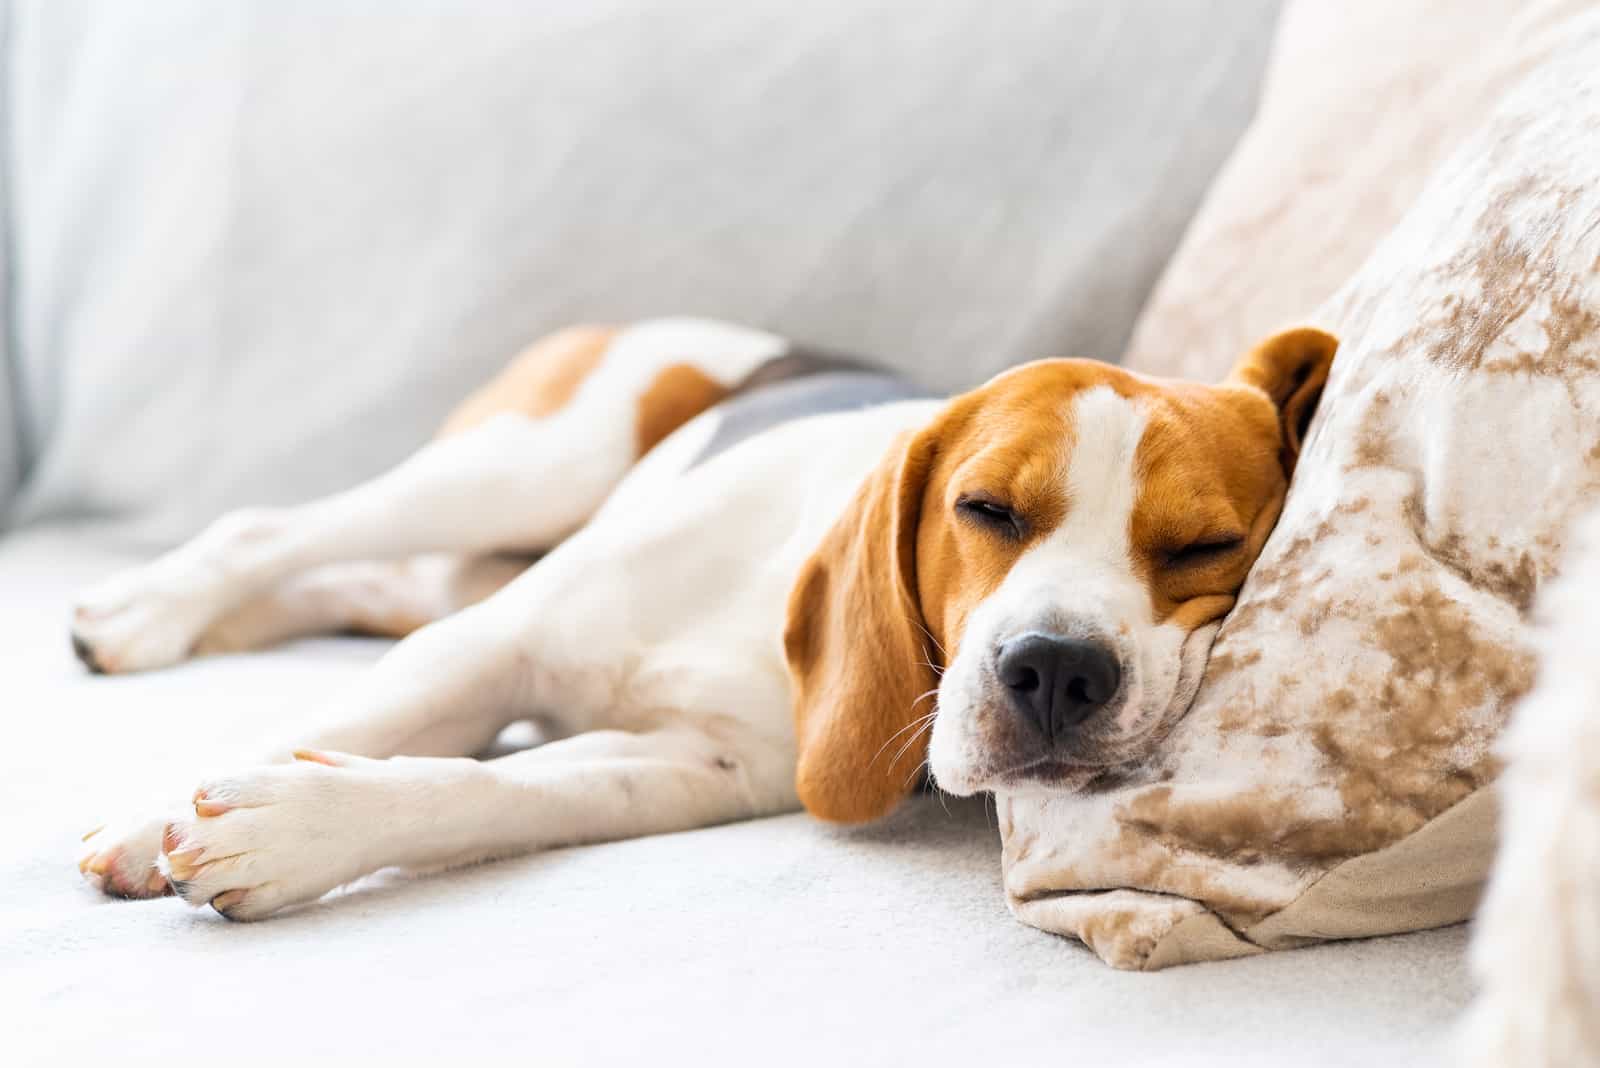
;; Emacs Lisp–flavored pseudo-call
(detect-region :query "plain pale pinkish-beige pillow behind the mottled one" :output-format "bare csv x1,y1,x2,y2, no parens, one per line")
1125,0,1594,382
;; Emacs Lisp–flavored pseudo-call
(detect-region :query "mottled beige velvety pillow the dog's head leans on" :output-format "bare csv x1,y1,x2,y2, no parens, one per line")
1000,10,1600,969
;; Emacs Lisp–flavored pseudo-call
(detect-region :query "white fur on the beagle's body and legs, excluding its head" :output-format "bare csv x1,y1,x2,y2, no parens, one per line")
77,313,938,919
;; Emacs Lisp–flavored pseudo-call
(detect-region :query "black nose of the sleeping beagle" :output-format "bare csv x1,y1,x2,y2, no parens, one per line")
995,633,1122,739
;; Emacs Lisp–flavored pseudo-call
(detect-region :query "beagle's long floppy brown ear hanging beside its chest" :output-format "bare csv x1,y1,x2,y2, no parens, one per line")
784,432,938,823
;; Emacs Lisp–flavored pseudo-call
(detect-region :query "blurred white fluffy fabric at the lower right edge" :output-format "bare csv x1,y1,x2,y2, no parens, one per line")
1462,513,1600,1068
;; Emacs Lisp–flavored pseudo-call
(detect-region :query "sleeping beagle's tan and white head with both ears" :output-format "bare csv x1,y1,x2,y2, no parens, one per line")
784,328,1338,822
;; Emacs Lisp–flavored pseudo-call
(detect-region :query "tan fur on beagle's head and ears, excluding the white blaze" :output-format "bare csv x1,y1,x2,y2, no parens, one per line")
784,329,1338,822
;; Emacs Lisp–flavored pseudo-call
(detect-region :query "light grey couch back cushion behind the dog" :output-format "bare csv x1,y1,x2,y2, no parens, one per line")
0,0,1277,540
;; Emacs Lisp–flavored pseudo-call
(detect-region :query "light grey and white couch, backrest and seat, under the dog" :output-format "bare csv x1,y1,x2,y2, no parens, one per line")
0,0,1469,1068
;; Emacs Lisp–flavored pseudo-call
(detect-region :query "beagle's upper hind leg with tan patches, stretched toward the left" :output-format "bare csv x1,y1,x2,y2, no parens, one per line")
72,320,784,671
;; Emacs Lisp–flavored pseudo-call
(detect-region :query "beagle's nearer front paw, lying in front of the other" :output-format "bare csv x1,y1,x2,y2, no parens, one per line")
160,751,394,919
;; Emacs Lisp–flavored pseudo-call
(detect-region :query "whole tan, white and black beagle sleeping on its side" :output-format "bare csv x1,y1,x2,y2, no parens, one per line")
72,320,1336,919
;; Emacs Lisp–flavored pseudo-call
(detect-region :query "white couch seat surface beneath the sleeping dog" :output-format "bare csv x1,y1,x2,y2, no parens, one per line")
0,531,1469,1068
